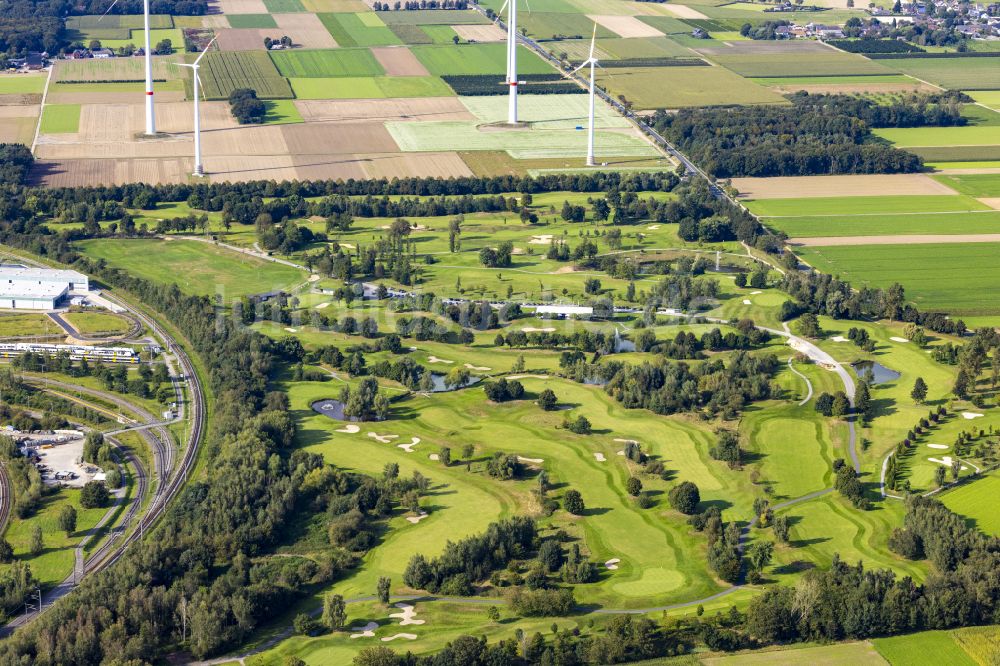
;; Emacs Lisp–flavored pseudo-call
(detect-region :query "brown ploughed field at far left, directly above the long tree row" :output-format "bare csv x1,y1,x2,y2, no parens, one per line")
33,158,192,187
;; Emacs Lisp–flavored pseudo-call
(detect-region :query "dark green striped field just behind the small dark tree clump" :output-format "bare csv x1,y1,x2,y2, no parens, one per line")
200,51,292,99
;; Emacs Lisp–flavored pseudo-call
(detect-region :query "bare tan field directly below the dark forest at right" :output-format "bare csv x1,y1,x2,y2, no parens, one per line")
732,173,957,199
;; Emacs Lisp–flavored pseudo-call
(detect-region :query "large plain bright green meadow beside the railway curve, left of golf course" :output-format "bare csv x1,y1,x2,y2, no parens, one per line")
79,239,306,300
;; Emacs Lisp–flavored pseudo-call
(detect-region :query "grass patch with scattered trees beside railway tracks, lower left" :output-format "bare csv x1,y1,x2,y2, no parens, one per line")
0,488,107,587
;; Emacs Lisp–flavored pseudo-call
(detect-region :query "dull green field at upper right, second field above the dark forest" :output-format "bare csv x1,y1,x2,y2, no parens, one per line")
708,51,892,78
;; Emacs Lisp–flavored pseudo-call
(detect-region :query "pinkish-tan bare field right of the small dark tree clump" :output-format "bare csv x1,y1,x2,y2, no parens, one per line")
295,97,476,123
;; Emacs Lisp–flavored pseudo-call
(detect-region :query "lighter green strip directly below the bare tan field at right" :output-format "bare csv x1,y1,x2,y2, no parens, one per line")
743,195,990,221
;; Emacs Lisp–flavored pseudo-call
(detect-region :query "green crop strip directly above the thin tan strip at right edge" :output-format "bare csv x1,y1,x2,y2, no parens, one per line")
764,211,1000,238
